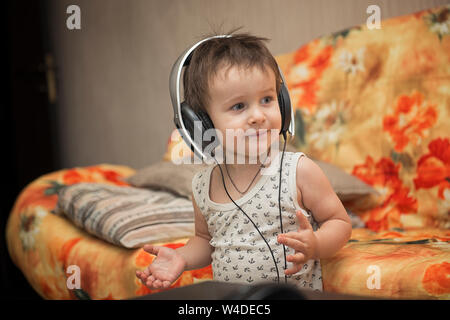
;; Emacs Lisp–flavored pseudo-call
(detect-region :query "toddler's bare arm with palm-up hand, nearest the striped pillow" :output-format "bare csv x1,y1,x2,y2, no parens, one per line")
136,197,213,289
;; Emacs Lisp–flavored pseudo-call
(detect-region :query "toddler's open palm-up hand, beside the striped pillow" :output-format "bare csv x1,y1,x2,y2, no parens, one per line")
136,244,186,289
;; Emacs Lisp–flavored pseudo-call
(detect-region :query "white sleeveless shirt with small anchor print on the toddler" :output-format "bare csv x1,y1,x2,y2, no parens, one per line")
192,152,323,291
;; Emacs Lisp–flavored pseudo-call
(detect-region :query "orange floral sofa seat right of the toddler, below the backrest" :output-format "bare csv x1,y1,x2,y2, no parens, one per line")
321,228,450,299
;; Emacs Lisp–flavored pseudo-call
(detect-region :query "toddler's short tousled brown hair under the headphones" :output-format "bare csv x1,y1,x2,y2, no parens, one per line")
183,29,281,112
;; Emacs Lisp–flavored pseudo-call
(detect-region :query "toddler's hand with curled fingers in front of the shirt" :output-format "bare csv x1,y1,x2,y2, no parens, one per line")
278,210,318,275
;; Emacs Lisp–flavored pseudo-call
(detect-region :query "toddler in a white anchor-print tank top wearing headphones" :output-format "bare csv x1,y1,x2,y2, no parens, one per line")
136,33,352,291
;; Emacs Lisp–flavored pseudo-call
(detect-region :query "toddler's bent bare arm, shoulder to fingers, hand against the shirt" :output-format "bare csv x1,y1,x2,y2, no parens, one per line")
279,157,352,274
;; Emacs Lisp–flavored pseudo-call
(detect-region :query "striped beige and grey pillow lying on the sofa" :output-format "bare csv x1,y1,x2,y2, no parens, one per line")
56,183,194,248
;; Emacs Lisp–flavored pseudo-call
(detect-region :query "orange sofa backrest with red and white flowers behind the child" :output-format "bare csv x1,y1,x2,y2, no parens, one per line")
277,6,450,231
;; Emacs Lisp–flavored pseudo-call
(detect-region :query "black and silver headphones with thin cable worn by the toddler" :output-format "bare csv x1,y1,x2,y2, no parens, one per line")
169,35,295,283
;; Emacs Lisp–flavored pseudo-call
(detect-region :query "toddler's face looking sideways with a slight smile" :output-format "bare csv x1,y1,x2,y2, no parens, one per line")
206,66,281,160
